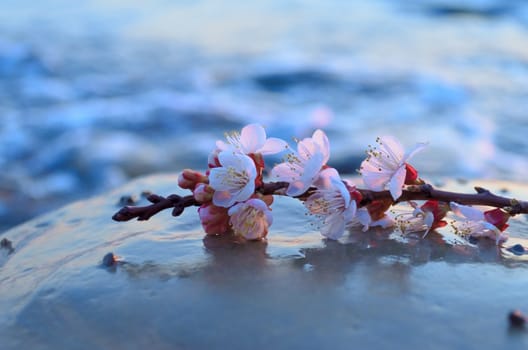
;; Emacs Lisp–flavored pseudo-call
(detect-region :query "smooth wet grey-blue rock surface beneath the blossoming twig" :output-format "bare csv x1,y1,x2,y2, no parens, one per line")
0,175,528,350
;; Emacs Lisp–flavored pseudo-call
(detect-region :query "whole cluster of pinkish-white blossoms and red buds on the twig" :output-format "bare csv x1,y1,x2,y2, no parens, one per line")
178,124,510,244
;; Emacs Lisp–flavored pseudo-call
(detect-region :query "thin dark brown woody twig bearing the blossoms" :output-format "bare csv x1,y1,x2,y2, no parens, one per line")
112,182,528,221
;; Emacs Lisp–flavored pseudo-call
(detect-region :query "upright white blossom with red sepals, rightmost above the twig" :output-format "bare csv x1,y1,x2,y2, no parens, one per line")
360,136,427,200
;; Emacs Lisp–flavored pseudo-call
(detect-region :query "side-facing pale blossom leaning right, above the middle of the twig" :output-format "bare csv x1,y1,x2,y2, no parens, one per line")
271,130,330,197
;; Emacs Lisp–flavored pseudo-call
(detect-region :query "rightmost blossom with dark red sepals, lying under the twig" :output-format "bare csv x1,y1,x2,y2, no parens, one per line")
449,202,510,245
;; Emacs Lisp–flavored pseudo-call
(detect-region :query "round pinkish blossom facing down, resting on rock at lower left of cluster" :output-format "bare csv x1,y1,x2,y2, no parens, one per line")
228,198,273,239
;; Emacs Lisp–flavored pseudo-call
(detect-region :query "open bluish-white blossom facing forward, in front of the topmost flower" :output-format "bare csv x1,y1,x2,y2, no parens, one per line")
209,151,257,208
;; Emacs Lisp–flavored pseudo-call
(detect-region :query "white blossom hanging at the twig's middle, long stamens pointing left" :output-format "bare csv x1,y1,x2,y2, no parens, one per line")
304,169,357,239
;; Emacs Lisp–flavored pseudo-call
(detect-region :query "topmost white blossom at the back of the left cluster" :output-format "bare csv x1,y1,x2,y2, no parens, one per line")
216,124,288,155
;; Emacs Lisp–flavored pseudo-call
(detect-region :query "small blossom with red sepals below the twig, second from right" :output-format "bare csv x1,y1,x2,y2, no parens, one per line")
396,200,449,238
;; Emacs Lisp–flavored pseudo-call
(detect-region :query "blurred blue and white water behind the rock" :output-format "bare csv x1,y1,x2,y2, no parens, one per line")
0,0,528,232
